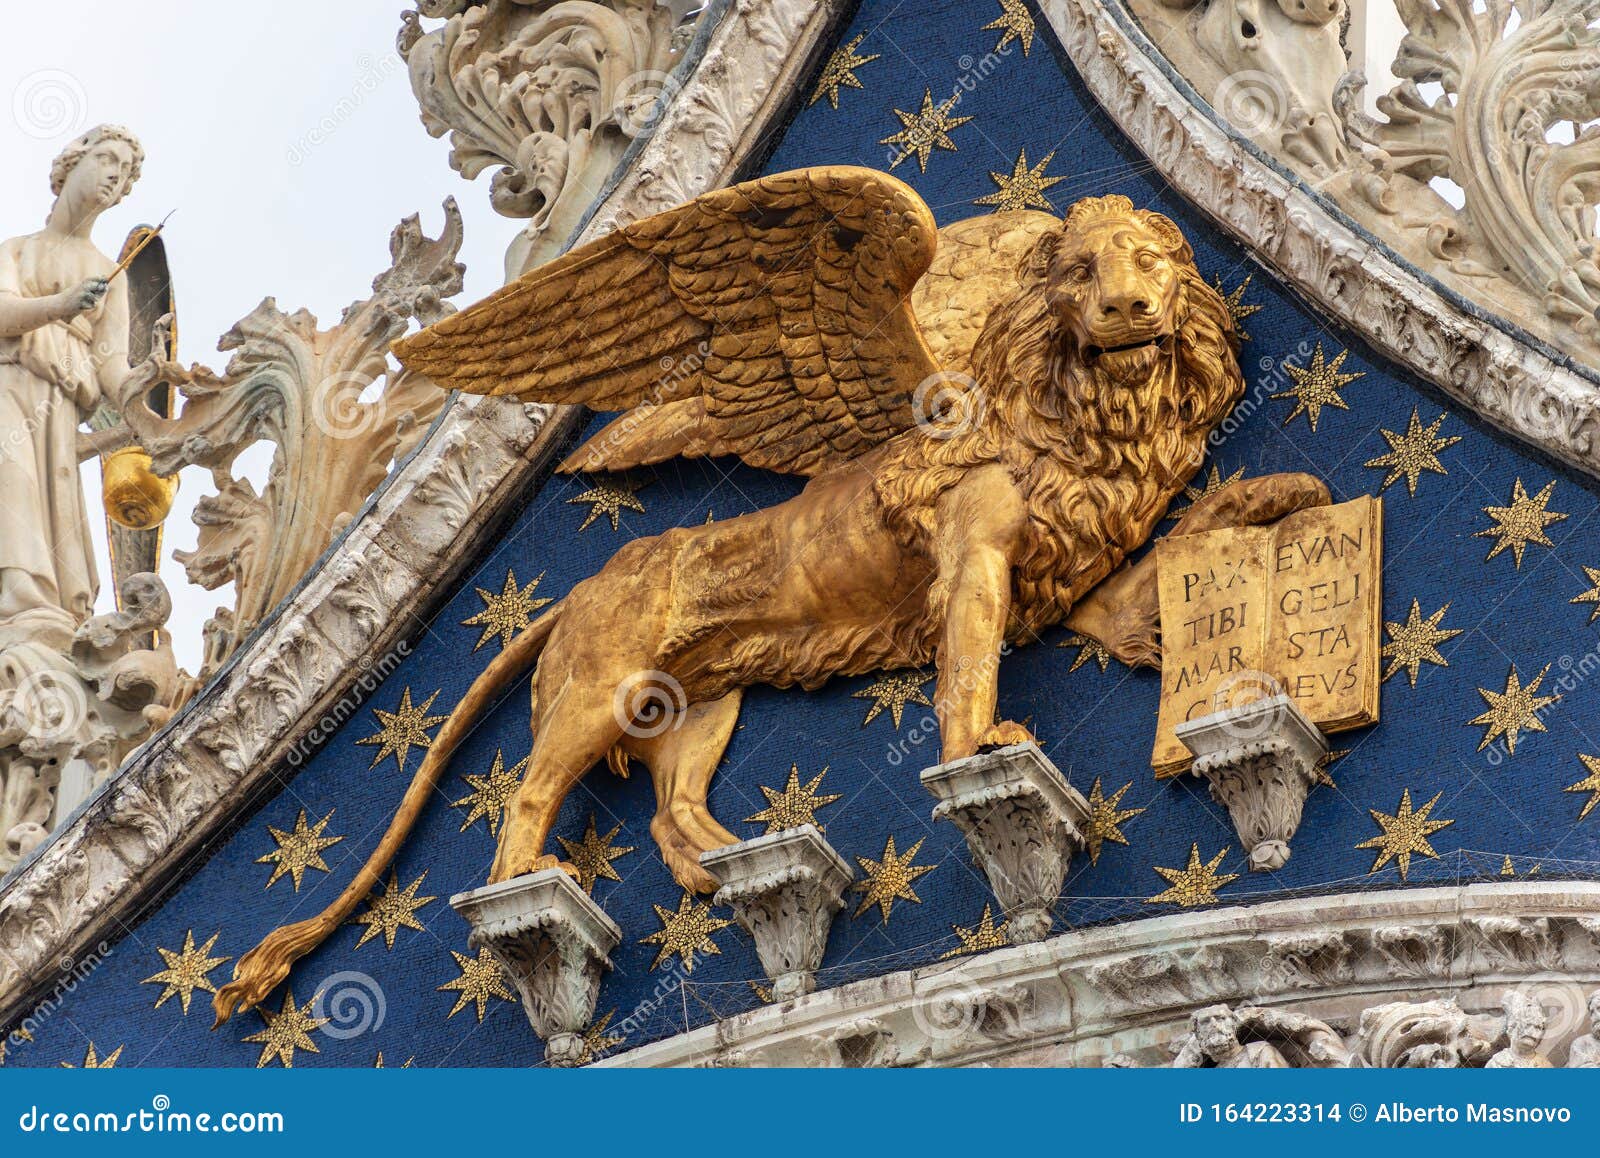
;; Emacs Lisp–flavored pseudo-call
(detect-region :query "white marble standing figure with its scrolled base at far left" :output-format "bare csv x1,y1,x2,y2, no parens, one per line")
0,125,174,872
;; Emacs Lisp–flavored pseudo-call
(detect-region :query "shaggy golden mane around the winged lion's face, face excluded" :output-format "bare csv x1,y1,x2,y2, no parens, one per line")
877,198,1245,635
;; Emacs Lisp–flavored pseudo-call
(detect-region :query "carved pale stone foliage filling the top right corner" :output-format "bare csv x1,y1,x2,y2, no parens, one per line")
1133,0,1600,365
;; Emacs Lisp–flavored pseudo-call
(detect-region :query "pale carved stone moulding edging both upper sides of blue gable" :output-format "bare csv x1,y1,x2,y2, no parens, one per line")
0,0,1600,1027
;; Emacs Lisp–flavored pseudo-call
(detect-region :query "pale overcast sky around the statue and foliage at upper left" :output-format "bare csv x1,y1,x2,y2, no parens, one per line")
0,0,517,670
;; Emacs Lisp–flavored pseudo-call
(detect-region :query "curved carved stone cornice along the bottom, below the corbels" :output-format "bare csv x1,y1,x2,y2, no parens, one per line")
600,881,1600,1067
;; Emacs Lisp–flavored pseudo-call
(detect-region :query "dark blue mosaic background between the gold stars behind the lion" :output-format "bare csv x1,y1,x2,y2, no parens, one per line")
6,0,1600,1067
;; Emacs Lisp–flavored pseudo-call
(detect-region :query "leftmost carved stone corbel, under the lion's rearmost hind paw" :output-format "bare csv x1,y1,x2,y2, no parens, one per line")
450,869,622,1065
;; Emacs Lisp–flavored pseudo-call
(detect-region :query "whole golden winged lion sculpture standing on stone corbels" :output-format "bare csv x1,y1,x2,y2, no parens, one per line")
214,166,1328,1020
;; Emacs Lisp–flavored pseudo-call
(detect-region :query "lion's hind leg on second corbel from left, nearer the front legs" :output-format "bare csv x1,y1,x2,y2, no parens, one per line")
622,691,744,892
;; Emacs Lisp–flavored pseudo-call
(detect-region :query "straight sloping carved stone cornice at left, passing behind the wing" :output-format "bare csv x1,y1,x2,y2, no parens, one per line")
0,0,842,1025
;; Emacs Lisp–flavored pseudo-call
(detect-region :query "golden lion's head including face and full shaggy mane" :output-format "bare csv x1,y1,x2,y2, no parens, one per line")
880,197,1245,627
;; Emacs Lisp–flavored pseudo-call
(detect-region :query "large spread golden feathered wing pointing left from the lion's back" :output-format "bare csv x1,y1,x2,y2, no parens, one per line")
395,166,939,475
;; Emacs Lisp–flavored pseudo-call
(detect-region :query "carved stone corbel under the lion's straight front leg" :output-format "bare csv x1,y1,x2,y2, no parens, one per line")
922,744,1088,945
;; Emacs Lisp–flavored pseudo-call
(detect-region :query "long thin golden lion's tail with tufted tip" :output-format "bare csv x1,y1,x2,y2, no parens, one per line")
211,603,562,1028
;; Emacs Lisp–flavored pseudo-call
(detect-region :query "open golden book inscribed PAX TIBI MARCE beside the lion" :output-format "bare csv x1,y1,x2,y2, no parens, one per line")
1150,497,1384,777
